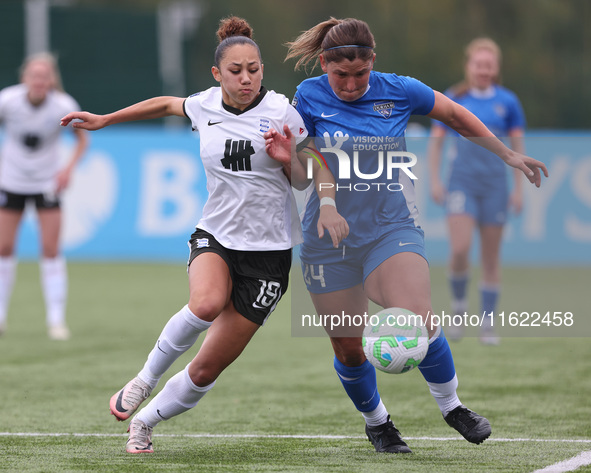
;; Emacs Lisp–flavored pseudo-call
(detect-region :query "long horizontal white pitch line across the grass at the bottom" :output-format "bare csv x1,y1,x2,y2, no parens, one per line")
0,432,591,444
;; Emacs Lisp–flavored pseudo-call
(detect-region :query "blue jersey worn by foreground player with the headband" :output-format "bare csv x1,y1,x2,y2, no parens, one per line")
293,71,435,249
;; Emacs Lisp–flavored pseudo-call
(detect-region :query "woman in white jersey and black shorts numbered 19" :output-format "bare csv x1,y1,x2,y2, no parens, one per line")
62,17,346,453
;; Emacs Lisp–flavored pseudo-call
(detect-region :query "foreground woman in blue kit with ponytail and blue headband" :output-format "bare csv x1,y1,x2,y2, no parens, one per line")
287,18,547,453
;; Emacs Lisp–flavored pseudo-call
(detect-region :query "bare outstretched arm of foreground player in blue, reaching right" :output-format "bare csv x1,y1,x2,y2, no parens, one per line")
428,92,548,187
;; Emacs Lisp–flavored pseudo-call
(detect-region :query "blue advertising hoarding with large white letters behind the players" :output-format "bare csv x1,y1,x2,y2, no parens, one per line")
12,126,591,265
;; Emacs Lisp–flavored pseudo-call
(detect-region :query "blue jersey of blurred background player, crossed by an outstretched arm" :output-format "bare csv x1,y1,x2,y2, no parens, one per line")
433,85,525,180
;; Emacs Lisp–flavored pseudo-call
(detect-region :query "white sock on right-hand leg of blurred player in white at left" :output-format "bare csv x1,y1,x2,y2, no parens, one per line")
39,256,68,327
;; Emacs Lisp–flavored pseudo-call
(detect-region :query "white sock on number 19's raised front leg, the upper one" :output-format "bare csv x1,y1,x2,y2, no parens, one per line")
138,305,211,389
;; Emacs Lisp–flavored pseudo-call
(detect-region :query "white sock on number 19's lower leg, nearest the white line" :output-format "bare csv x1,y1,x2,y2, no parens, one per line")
136,365,215,427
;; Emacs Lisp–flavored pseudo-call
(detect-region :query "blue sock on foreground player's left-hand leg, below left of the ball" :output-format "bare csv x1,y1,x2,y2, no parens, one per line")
334,356,380,412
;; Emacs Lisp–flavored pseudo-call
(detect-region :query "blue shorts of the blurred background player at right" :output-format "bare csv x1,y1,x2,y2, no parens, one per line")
445,173,509,225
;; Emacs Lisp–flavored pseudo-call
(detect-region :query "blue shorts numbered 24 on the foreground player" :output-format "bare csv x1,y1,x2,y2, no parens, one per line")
300,226,427,294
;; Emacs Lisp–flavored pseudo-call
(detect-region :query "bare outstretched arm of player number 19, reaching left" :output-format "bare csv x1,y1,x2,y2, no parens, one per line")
60,96,185,130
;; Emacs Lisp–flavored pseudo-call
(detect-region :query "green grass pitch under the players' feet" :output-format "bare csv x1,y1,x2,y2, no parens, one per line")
0,263,591,473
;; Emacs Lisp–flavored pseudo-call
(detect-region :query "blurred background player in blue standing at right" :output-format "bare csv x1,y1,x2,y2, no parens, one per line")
428,38,525,345
